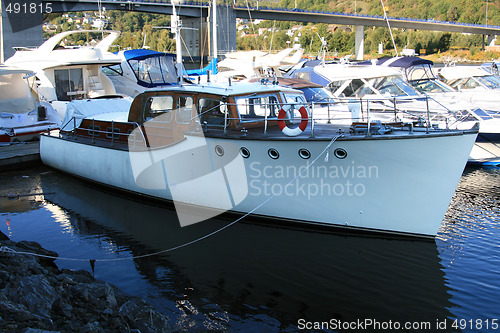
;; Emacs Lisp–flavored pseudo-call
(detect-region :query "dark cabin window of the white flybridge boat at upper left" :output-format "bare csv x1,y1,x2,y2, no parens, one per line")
54,68,85,101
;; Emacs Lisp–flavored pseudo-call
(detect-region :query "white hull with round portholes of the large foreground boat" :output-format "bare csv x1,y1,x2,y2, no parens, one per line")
40,132,477,237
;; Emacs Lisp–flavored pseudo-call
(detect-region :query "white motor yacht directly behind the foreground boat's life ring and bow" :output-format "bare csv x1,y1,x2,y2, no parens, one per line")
284,60,454,124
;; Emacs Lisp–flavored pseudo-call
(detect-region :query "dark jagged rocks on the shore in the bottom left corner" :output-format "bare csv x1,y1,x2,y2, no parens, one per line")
0,233,174,333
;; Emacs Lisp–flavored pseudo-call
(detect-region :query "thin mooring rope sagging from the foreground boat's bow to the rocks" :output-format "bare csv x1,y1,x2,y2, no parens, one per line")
0,134,343,264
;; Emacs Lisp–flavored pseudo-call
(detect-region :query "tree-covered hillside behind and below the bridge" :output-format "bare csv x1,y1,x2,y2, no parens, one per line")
44,0,500,59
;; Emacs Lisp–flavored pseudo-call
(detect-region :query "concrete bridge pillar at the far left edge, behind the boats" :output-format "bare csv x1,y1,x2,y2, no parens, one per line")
0,6,43,63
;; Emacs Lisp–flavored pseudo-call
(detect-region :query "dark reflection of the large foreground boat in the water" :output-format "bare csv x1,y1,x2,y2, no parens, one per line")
41,172,451,327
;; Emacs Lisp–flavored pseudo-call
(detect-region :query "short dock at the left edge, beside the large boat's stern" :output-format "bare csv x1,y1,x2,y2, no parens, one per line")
0,141,41,171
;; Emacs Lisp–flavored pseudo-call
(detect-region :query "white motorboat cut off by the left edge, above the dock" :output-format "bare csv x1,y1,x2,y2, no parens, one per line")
0,65,60,144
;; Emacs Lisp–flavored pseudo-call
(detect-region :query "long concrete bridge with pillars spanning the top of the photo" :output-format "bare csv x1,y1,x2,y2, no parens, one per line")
0,0,500,61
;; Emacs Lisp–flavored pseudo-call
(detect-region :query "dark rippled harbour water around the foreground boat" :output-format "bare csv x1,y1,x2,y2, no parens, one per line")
0,167,500,332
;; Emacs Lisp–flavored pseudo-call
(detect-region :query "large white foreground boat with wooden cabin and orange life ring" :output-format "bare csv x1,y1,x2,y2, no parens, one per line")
40,79,477,237
